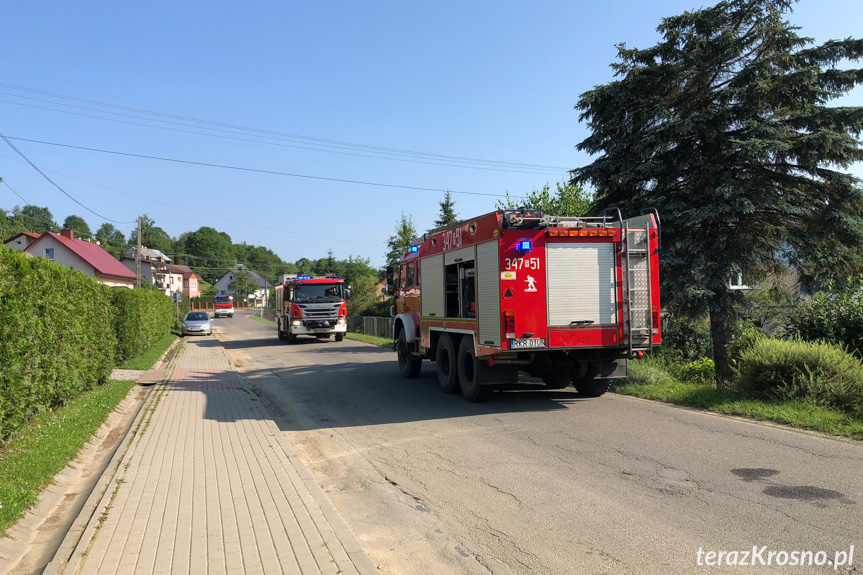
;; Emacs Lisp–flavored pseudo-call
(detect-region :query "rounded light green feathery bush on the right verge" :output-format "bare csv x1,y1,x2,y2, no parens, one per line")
736,339,863,416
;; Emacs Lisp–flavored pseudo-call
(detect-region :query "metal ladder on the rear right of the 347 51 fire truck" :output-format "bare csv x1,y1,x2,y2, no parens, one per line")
606,208,658,355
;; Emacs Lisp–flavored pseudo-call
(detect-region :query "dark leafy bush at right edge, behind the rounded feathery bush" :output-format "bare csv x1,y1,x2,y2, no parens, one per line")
788,287,863,357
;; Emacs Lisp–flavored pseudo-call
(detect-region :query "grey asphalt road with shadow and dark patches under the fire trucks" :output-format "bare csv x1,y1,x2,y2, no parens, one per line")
215,313,863,574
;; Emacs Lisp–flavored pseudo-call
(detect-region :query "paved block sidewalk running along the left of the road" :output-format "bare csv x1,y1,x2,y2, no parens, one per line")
45,337,377,575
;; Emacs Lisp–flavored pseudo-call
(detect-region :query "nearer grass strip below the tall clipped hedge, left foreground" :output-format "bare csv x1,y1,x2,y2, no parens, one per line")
0,381,135,534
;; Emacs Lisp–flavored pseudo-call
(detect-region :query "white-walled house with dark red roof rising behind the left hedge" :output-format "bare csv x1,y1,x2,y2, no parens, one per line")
24,230,137,288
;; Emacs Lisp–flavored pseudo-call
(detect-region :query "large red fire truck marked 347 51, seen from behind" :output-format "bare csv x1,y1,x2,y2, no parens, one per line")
387,208,662,401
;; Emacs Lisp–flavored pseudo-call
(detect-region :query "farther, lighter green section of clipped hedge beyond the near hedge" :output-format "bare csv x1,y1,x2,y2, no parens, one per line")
112,289,175,363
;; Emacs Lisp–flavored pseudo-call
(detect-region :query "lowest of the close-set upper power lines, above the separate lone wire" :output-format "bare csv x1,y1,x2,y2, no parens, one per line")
0,98,566,175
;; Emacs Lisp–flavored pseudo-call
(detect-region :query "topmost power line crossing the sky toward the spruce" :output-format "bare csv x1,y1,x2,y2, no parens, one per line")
0,83,569,172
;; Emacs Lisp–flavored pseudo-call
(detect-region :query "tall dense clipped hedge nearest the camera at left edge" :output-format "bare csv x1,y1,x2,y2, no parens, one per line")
0,248,117,439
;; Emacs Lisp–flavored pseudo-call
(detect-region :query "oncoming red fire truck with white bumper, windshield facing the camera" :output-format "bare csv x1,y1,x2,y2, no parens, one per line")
276,276,349,343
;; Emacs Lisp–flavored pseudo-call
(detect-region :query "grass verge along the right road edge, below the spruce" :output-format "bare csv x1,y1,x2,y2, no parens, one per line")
612,360,863,439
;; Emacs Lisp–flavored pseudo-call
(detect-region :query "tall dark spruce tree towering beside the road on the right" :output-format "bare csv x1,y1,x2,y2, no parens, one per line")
573,0,863,379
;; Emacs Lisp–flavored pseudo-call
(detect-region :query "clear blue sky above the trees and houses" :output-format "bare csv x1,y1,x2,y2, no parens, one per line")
0,0,863,265
